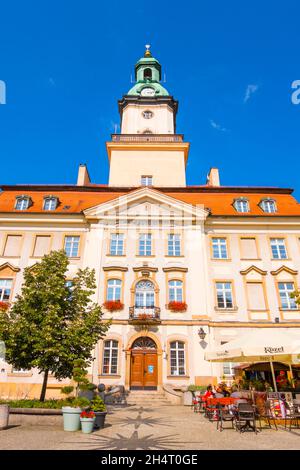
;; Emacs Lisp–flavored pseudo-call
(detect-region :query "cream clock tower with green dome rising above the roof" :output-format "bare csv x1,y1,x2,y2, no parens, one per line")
106,45,189,187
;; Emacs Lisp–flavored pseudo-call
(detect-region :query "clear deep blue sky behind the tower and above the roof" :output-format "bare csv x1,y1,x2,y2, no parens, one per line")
0,0,300,200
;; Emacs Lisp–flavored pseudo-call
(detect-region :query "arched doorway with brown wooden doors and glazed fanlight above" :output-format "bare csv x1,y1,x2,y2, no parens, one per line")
130,336,157,390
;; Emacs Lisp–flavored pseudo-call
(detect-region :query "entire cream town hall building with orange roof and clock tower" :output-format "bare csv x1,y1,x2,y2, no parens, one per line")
0,47,300,397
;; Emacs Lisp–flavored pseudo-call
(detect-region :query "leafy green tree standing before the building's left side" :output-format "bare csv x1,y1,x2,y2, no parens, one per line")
0,250,110,401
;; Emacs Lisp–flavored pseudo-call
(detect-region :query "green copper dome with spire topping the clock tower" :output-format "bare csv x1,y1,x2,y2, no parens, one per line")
127,45,169,97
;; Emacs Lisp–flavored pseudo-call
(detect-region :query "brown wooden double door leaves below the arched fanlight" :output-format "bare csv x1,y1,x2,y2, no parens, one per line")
130,350,157,390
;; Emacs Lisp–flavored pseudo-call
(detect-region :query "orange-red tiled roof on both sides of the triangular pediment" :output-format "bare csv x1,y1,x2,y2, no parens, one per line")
0,185,300,217
